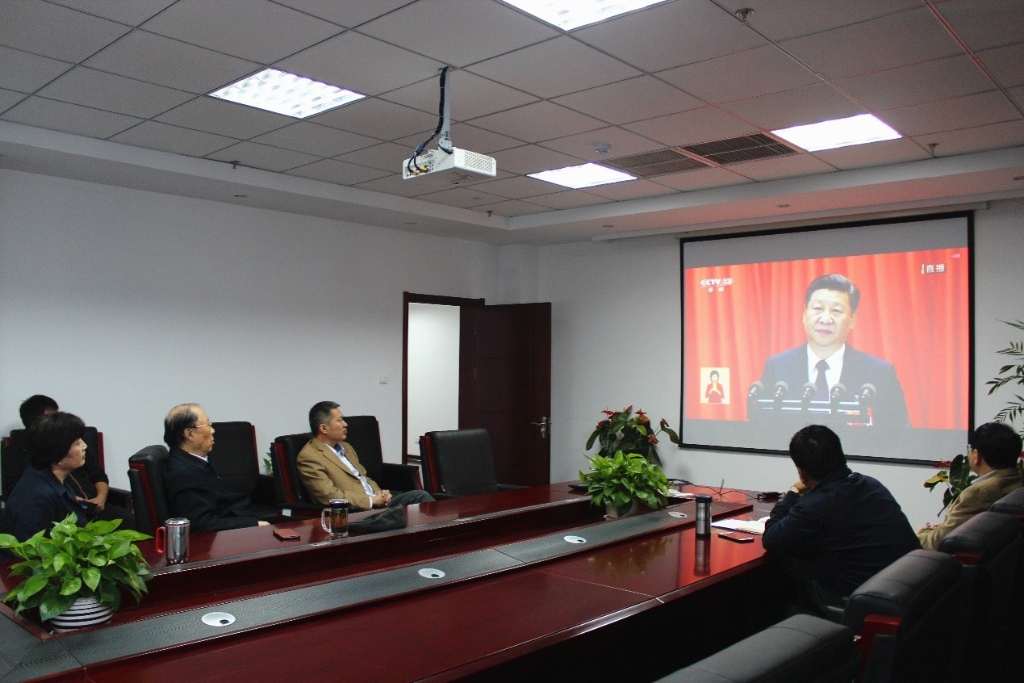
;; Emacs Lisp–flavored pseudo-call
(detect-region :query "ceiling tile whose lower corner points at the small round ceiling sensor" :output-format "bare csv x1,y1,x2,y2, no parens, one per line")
554,76,706,124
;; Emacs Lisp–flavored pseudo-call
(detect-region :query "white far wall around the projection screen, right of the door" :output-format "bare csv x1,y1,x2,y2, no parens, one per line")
539,202,1024,525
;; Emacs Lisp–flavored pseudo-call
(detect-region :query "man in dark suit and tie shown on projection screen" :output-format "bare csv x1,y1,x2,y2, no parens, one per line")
761,274,910,427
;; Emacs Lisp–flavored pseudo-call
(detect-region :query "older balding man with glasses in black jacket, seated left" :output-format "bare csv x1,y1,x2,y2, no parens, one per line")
164,403,267,533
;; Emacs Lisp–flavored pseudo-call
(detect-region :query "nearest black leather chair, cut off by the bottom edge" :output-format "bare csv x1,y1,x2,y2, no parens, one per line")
657,614,860,683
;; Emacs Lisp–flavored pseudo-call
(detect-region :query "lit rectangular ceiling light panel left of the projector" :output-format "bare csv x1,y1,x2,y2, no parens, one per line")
210,69,366,119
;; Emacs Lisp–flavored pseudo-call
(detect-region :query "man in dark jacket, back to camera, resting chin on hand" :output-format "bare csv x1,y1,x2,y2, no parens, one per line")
762,425,921,615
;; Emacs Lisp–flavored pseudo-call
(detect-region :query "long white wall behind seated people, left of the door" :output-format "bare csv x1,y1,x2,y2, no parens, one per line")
0,171,498,486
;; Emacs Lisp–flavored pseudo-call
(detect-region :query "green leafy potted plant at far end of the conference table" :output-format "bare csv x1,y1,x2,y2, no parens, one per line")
580,451,669,518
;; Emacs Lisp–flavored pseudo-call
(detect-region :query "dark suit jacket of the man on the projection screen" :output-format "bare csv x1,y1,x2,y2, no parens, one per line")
761,344,910,427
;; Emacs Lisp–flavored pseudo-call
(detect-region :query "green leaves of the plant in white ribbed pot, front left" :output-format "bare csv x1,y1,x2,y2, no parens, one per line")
0,515,153,622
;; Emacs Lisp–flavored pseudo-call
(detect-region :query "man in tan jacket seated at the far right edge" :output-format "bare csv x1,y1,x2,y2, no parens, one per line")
918,422,1022,550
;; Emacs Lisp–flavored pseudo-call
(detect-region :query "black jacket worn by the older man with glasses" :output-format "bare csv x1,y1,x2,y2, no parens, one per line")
165,449,259,533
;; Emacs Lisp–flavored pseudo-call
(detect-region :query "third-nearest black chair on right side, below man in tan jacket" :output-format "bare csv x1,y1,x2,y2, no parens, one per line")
939,511,1021,681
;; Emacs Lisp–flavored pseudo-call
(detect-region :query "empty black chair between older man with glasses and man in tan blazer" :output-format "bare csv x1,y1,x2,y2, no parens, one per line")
207,422,278,521
